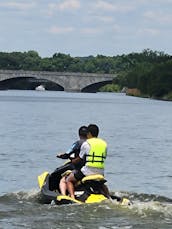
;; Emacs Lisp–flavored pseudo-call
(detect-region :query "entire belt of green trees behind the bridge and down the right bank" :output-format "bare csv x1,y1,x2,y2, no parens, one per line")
0,49,172,100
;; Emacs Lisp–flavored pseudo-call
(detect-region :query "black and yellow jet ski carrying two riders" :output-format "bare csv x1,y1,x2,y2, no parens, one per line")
38,162,132,205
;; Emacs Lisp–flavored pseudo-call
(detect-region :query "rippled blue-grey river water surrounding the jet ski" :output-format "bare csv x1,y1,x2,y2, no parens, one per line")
0,90,172,229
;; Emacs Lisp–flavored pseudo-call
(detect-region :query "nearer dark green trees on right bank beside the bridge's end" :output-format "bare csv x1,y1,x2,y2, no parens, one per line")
113,50,172,100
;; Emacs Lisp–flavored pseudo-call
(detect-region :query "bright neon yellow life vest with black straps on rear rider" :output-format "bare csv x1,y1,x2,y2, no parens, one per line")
85,138,107,169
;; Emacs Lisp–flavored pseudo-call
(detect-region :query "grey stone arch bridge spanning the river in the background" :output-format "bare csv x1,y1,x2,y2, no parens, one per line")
0,70,117,92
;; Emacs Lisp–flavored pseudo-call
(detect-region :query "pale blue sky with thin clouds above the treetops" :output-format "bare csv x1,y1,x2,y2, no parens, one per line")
0,0,172,57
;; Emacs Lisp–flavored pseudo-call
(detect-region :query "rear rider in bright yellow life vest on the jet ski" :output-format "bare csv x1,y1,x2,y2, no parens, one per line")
66,124,109,198
